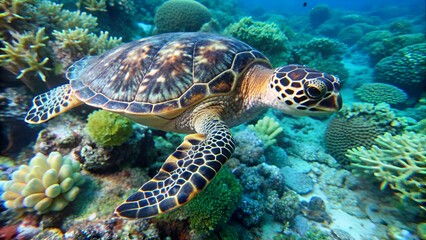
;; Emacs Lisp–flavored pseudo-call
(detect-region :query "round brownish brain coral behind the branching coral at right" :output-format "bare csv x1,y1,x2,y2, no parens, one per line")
325,103,400,164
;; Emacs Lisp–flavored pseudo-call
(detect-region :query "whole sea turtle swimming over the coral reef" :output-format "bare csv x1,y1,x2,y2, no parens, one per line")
25,33,342,218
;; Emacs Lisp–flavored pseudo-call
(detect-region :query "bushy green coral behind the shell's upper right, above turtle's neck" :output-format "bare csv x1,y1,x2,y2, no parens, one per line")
224,17,287,53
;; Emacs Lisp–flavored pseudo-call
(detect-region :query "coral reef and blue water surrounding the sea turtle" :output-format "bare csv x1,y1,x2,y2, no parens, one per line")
0,0,426,240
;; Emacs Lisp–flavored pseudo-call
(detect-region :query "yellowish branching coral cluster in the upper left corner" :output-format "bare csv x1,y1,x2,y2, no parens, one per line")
0,0,121,91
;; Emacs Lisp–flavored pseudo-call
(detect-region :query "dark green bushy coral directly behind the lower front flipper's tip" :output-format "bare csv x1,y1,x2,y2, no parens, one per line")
169,166,243,235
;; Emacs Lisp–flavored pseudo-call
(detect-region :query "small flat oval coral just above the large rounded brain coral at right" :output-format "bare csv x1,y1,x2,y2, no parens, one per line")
355,83,407,104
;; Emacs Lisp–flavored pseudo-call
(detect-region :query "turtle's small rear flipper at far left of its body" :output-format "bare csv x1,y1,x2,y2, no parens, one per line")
25,84,82,124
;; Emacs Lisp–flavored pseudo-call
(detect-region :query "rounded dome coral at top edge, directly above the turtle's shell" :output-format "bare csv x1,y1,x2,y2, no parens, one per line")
154,0,211,33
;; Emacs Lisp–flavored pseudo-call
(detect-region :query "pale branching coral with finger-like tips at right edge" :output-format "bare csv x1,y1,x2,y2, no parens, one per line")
346,132,426,204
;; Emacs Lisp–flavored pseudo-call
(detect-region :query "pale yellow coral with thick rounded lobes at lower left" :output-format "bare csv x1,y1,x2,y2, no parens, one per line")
1,152,84,214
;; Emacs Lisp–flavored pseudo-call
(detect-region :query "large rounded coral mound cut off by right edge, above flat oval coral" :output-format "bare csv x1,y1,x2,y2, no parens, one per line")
375,43,426,93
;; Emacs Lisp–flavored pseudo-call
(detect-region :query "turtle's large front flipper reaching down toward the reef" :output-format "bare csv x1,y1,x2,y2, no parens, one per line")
115,120,235,218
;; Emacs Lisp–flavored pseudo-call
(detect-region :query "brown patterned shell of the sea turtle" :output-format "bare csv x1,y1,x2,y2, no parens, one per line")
67,33,270,115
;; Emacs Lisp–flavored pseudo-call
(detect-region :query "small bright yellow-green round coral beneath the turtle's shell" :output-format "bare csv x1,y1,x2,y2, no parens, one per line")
86,110,133,146
